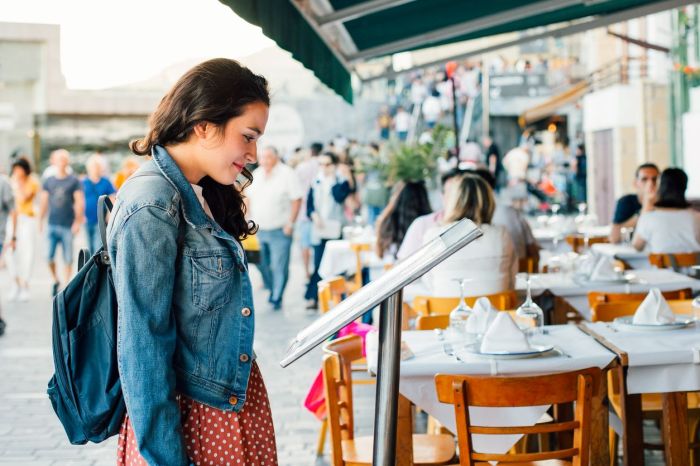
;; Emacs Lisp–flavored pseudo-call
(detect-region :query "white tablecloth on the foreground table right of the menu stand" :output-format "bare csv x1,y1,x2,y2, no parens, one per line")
367,325,615,453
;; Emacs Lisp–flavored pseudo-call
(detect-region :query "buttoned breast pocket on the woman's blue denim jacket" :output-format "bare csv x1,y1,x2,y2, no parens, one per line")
190,251,235,311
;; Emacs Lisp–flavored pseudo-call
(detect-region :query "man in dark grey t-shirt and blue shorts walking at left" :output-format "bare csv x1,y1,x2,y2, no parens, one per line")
39,149,85,296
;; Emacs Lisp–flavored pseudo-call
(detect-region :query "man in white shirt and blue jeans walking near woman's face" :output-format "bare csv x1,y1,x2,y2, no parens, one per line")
246,147,304,311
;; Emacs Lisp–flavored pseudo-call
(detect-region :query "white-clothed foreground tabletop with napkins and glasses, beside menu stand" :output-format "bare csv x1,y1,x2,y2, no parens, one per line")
366,298,615,453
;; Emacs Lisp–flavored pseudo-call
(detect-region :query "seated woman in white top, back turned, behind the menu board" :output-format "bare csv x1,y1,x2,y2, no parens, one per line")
424,173,518,296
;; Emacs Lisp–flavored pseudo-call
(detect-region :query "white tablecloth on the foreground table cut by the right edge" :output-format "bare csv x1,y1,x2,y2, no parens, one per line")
587,322,700,393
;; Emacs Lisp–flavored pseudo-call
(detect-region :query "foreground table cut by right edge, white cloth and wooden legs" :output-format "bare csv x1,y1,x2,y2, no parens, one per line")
581,322,700,466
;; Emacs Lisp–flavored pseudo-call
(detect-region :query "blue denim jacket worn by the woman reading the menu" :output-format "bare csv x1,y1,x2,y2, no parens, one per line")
107,146,254,466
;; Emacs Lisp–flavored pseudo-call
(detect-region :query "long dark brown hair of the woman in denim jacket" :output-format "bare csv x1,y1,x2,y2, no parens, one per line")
129,58,270,240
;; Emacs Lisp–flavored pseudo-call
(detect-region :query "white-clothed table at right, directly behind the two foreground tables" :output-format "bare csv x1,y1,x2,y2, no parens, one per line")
515,269,700,323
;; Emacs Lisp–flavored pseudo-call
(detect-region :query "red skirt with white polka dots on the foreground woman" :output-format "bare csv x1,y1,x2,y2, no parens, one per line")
117,363,277,466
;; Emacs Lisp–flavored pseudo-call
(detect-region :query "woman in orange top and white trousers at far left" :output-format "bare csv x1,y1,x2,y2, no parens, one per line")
7,158,41,301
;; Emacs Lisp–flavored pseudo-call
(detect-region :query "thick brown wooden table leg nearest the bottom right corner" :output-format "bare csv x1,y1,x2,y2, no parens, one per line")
663,392,690,466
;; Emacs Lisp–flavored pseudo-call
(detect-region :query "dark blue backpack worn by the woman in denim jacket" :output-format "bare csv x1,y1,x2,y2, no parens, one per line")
47,196,126,444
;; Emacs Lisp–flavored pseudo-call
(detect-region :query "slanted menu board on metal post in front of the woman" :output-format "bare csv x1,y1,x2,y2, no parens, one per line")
280,219,482,466
